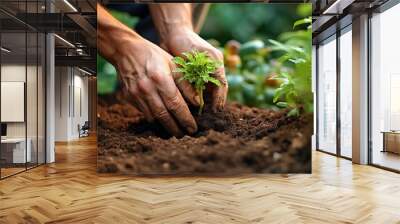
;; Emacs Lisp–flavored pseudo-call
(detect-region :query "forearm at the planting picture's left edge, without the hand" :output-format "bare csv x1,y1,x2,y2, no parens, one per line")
97,3,143,63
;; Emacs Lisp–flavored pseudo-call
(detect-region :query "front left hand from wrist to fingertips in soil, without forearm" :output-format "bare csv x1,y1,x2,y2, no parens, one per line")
112,38,199,137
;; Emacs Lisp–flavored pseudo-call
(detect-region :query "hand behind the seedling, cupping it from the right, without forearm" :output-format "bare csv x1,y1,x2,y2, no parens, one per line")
161,28,228,110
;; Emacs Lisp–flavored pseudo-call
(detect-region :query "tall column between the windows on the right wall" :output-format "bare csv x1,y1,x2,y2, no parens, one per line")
352,15,368,164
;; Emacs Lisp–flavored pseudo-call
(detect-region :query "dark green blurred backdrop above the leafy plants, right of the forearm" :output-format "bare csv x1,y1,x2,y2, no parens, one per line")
200,3,311,45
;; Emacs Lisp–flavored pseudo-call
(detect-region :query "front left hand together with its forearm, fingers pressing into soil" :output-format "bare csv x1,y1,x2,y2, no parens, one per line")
97,4,200,136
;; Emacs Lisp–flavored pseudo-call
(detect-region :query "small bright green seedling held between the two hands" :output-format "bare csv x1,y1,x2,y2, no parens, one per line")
173,51,221,115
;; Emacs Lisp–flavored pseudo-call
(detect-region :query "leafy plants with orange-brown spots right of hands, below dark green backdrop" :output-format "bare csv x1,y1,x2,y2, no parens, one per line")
223,4,313,116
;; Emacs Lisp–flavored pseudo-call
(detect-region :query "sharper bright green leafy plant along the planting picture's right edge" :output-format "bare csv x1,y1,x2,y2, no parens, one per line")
269,17,313,116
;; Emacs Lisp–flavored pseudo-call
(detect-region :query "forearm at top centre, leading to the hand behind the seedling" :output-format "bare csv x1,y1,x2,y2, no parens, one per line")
149,3,193,42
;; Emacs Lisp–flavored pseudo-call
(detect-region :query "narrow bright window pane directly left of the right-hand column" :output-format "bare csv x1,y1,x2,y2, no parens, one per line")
340,30,353,158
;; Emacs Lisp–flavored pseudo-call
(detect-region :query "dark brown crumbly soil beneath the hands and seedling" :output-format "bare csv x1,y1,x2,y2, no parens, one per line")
98,94,312,175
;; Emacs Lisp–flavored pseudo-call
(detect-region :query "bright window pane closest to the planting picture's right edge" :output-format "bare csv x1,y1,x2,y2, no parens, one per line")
318,37,336,153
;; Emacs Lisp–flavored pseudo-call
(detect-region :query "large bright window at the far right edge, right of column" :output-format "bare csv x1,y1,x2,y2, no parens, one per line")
371,5,400,170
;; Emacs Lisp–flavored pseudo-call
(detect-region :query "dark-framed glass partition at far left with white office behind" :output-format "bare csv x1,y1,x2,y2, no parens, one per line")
0,0,45,177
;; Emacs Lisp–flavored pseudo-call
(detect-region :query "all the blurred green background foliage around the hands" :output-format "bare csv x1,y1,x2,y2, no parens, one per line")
98,3,313,116
